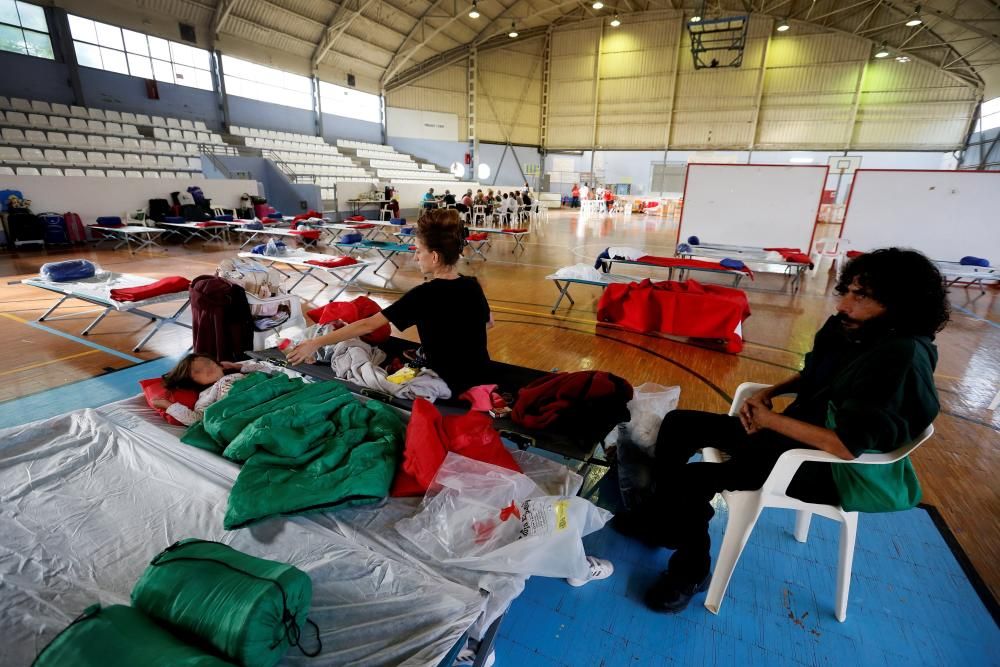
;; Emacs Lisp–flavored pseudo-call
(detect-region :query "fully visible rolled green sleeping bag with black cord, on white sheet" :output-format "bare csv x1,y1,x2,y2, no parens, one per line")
132,539,312,667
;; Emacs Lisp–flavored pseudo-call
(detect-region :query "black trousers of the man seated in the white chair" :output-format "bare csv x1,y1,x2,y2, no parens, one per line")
648,410,840,583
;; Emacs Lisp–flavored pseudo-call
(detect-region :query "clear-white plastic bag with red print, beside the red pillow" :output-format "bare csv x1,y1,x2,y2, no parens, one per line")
396,452,611,579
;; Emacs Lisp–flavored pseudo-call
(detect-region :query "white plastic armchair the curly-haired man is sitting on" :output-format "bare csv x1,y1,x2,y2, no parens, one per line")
702,382,934,623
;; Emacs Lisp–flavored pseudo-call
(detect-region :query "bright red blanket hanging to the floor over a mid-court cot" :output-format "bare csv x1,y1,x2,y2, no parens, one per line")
597,280,750,353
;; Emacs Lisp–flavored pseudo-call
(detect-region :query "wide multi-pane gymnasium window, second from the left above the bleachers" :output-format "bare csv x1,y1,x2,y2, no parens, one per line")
69,14,212,90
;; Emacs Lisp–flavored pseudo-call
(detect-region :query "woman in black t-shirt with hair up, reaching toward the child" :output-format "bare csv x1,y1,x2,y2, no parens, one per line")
288,209,493,395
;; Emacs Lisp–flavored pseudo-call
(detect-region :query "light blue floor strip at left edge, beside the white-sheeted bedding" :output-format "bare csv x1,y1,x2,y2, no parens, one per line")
0,357,178,428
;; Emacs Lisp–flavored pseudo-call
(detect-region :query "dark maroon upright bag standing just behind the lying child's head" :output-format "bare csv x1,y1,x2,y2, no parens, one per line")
191,276,254,361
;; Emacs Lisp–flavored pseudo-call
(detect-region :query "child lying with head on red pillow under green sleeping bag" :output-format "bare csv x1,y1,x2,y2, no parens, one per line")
153,353,292,426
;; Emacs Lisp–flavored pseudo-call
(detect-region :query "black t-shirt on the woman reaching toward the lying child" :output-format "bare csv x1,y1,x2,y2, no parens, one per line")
382,276,490,396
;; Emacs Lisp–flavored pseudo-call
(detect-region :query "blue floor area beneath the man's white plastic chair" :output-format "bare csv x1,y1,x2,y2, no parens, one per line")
496,504,1000,667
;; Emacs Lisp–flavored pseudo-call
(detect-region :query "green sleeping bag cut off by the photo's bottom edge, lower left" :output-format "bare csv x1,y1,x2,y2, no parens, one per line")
32,604,232,667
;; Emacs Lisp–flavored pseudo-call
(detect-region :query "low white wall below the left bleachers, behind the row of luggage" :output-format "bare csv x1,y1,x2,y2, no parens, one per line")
0,176,259,225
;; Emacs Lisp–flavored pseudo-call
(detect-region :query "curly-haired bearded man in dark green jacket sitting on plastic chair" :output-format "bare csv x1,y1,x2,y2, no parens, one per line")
612,248,949,612
